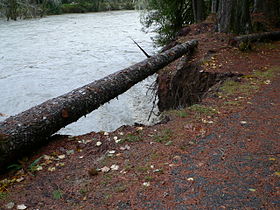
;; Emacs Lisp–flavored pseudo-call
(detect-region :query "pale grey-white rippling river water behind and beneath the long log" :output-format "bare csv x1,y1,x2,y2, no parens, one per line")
0,11,160,135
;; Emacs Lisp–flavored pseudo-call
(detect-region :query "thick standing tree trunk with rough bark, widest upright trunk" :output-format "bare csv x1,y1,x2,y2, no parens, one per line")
218,0,251,34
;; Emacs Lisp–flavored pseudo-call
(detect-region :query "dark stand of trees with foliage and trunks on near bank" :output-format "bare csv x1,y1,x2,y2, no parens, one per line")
142,0,280,45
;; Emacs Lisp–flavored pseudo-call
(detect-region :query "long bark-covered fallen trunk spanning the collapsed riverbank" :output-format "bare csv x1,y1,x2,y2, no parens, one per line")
0,40,198,170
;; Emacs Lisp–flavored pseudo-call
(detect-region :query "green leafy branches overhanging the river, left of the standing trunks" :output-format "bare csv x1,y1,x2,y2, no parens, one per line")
141,0,193,46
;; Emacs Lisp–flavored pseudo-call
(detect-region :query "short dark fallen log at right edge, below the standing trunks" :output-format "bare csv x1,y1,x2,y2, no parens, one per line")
230,31,280,46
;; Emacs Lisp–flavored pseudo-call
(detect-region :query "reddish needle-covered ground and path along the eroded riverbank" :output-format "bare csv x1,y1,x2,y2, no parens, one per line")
0,25,280,209
